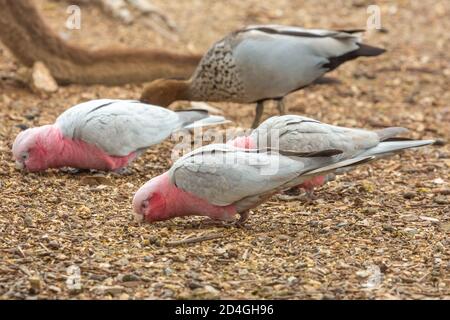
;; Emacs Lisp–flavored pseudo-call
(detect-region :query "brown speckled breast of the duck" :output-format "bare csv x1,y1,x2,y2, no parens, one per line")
192,39,245,102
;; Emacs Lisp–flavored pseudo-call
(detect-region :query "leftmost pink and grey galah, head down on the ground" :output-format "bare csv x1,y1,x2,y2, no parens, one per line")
12,99,227,171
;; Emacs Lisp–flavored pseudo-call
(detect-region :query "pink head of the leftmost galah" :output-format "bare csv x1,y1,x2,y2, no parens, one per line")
12,125,62,172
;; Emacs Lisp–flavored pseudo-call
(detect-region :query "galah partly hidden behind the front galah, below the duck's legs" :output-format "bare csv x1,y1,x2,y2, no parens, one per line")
228,115,430,197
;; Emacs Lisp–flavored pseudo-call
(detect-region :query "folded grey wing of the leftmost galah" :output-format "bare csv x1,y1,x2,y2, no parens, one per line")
56,100,181,156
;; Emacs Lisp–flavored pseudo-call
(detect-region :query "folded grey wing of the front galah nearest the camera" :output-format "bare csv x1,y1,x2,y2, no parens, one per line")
169,144,307,206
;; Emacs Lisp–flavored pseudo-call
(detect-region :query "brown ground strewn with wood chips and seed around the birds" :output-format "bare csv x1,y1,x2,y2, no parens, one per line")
0,0,450,299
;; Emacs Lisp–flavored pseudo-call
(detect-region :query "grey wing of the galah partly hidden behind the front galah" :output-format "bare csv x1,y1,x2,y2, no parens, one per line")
252,115,380,159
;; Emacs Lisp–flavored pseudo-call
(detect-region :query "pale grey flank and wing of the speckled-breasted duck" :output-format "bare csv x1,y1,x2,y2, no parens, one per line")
231,26,359,101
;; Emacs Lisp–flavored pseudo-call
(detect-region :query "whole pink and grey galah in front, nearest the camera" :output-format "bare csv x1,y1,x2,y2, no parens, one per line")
133,127,433,223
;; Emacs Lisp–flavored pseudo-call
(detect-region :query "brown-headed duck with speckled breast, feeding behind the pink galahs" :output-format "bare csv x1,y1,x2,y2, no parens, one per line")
141,25,385,128
